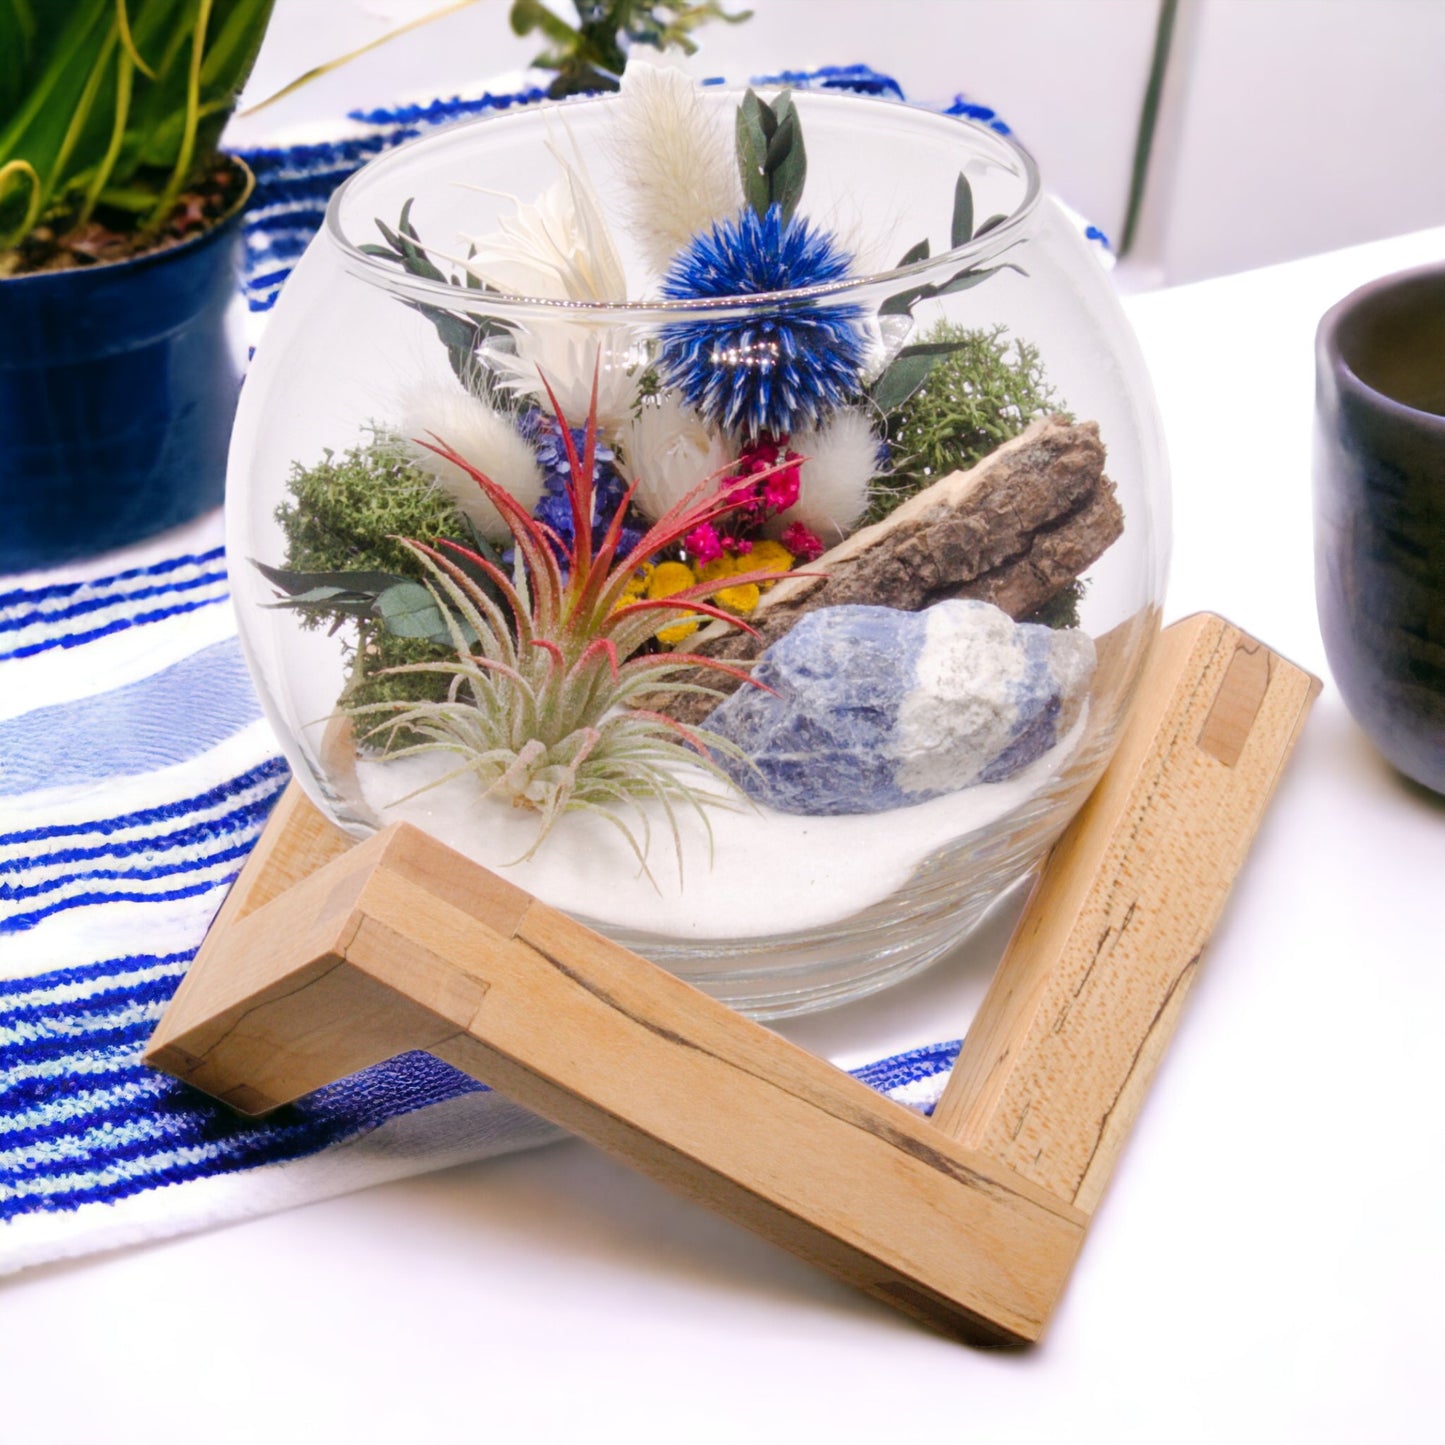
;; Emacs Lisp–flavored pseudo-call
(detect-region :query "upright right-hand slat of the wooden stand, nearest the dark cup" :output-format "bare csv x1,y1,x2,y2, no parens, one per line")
933,614,1319,1211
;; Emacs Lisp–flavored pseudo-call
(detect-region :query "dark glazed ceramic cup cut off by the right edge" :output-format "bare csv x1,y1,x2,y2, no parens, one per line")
1315,264,1445,793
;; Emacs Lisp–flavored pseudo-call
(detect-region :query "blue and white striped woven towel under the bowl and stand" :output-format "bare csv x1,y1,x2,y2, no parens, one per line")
0,66,1028,1273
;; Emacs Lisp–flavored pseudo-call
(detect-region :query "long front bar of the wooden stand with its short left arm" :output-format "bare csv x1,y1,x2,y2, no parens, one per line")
149,825,1082,1342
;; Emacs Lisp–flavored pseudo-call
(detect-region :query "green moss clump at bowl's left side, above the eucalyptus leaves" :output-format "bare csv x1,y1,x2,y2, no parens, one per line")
276,432,467,578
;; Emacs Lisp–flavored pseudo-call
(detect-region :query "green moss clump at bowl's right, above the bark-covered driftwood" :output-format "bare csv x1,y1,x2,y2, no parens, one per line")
864,321,1062,522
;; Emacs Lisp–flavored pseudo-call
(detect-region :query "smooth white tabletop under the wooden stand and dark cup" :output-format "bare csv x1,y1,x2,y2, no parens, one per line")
0,203,1445,1445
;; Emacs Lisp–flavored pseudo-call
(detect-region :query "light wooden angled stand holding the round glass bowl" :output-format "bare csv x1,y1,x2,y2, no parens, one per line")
147,616,1319,1344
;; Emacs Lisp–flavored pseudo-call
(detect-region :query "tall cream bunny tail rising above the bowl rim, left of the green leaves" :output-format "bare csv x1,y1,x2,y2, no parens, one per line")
614,58,743,272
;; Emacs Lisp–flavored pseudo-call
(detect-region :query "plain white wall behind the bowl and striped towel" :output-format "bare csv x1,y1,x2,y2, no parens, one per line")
238,0,1445,289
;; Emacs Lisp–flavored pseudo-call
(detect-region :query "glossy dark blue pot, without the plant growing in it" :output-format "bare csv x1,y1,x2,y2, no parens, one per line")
0,166,250,572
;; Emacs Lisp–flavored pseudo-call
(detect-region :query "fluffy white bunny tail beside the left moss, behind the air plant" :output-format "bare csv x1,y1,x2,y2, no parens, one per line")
403,386,542,542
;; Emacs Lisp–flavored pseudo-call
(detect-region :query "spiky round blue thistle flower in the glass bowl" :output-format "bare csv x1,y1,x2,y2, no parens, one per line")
657,205,867,441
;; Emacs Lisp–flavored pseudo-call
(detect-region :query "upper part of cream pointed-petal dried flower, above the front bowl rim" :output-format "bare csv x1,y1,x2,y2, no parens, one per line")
461,142,627,301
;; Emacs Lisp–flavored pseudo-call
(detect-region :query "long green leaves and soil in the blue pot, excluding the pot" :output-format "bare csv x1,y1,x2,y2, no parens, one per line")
0,0,275,276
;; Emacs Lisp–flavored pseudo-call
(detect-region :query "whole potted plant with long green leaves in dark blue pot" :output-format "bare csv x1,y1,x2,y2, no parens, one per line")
0,0,275,572
